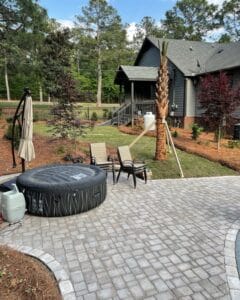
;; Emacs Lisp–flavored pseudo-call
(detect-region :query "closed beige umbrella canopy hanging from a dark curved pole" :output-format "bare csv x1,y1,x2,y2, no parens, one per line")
18,96,35,162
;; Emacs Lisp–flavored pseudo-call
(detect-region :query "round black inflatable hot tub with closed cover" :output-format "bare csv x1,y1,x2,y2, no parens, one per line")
16,164,107,217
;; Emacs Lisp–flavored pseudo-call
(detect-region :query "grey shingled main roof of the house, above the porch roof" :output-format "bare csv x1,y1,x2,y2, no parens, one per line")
138,37,240,76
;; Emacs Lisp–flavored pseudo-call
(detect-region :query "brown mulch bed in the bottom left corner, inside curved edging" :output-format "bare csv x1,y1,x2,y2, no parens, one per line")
0,246,62,300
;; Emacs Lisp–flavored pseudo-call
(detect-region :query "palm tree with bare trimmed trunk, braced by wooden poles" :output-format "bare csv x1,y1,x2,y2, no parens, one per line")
155,41,168,160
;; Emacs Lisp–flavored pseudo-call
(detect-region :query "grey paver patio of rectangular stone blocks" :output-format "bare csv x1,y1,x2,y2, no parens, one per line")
0,176,240,300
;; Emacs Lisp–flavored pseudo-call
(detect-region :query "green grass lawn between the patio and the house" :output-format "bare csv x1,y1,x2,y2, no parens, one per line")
34,124,239,179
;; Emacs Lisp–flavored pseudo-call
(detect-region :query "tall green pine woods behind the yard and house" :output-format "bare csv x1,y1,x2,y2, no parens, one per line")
0,0,240,106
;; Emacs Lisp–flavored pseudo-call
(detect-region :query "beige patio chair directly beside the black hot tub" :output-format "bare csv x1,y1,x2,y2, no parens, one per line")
90,143,116,183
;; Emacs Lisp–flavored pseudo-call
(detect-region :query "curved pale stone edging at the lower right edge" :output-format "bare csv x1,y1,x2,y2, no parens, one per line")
224,220,240,300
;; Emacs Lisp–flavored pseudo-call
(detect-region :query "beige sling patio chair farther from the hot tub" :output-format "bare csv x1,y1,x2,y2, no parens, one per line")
117,146,147,188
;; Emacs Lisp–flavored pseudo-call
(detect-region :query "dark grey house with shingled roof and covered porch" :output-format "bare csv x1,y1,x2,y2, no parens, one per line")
115,37,240,128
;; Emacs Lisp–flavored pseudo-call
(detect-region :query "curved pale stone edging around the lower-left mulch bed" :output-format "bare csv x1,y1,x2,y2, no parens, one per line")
1,244,76,300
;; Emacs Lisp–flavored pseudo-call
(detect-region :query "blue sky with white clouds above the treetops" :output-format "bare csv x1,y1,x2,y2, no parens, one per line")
39,0,223,39
